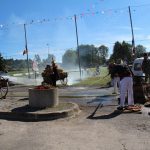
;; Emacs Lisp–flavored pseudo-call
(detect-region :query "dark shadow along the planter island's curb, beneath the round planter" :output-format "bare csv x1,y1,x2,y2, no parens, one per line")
0,105,69,122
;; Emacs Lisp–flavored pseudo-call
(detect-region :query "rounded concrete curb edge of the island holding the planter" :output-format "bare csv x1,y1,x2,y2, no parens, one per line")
0,103,81,122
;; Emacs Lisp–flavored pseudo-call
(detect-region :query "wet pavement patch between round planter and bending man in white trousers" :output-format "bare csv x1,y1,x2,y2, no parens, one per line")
59,87,118,106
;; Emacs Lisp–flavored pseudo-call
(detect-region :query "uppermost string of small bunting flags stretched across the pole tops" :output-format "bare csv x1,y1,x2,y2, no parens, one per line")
0,0,150,30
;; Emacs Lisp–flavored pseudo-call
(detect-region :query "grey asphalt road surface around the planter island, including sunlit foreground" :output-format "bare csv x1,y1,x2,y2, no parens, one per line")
0,87,150,150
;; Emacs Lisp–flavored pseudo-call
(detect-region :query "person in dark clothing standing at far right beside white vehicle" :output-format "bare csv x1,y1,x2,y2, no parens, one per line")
142,53,150,83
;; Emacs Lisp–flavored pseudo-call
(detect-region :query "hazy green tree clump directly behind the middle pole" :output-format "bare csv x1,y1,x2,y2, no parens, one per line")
62,45,108,67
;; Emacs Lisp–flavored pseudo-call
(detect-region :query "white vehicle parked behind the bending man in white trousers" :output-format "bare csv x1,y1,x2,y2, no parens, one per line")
132,57,145,76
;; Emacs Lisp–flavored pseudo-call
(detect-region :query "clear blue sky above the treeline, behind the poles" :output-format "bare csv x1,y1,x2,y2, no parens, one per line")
0,0,150,62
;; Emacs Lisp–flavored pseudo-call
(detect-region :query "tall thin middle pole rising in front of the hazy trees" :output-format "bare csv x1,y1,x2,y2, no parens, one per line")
74,15,81,80
